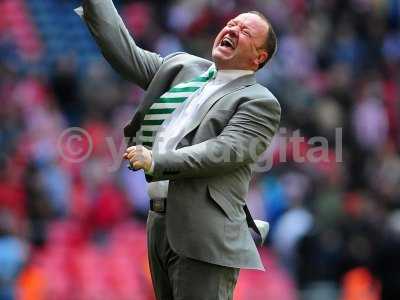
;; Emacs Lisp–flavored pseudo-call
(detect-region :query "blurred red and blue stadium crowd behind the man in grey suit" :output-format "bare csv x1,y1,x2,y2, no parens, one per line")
0,0,400,300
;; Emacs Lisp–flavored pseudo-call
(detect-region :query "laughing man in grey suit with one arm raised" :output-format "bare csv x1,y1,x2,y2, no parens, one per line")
76,0,280,300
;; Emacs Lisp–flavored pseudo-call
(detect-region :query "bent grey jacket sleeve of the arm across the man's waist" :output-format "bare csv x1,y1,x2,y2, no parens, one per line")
147,99,281,181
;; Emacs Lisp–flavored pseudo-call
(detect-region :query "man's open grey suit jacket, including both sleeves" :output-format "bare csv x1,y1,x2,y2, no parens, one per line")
76,0,281,270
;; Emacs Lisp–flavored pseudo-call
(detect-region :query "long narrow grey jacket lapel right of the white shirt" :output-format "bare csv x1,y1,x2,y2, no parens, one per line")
178,74,256,143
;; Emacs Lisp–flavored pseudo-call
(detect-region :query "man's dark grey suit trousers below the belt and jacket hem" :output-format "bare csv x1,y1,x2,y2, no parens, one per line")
147,211,239,300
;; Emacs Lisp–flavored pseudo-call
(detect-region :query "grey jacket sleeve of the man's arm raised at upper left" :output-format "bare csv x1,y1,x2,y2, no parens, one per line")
75,0,163,89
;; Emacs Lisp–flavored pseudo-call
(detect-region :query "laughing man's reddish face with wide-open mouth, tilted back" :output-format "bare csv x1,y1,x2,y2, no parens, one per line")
212,13,268,71
